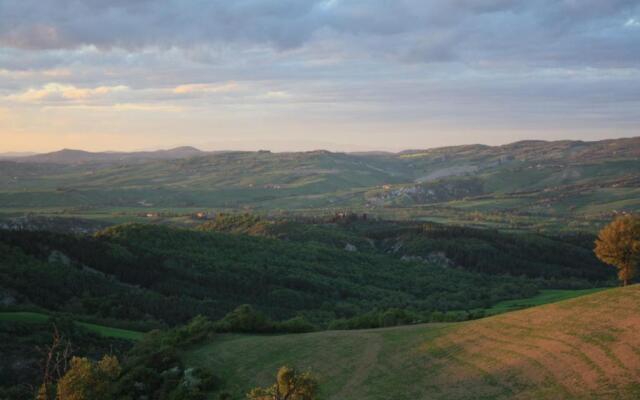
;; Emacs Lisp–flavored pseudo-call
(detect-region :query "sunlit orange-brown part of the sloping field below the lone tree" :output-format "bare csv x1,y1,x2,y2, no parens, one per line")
412,287,640,399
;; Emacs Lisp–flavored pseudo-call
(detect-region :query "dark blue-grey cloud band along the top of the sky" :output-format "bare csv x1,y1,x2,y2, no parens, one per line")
0,0,640,65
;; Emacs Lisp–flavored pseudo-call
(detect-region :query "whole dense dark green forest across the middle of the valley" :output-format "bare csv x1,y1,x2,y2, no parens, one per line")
0,216,613,326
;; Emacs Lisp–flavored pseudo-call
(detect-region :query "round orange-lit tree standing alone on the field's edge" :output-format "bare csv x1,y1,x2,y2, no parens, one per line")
595,215,640,286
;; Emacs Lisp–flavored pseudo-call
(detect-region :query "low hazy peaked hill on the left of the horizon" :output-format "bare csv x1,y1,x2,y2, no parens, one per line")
16,146,205,164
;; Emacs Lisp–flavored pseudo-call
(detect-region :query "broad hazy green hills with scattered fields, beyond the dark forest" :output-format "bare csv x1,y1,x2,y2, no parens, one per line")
0,138,640,231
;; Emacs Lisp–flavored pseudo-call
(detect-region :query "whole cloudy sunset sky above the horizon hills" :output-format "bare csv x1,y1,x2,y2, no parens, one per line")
0,0,640,152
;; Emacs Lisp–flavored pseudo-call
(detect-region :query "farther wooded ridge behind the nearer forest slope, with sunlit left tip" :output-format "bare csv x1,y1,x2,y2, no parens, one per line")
198,214,612,281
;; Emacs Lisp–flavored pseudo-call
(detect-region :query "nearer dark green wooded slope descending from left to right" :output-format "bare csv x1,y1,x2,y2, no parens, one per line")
0,225,556,326
